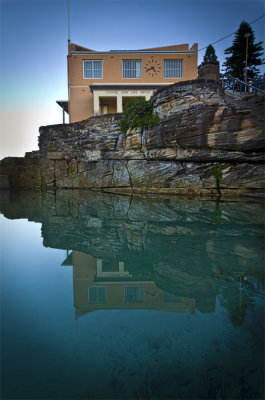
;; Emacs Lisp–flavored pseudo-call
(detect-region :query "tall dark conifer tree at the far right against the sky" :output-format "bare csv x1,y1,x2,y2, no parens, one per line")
223,21,264,80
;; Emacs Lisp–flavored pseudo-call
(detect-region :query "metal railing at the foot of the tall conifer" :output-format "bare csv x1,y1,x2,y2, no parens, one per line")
222,75,265,96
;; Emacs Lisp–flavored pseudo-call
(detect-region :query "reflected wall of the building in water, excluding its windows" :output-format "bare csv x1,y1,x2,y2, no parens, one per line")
72,251,195,315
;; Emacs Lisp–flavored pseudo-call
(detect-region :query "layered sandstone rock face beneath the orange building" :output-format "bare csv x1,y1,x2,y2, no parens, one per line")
0,80,265,196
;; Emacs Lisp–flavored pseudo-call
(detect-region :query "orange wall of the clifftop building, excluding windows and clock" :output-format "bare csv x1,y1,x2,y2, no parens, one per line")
68,44,198,122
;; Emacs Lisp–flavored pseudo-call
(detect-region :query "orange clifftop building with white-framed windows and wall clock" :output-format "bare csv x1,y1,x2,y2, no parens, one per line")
57,43,198,122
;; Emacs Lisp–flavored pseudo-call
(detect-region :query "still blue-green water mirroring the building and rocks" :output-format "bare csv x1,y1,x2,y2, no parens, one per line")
0,191,264,399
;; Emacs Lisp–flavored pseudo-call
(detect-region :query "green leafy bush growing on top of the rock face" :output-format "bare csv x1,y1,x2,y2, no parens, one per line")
120,97,160,133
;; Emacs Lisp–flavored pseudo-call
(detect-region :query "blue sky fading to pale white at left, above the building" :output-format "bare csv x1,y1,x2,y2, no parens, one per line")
0,0,265,159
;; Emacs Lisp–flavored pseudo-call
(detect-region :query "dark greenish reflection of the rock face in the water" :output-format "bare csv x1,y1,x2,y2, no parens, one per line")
1,191,264,324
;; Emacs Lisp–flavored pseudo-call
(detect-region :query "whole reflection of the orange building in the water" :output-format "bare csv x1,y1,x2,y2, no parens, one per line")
62,251,195,317
